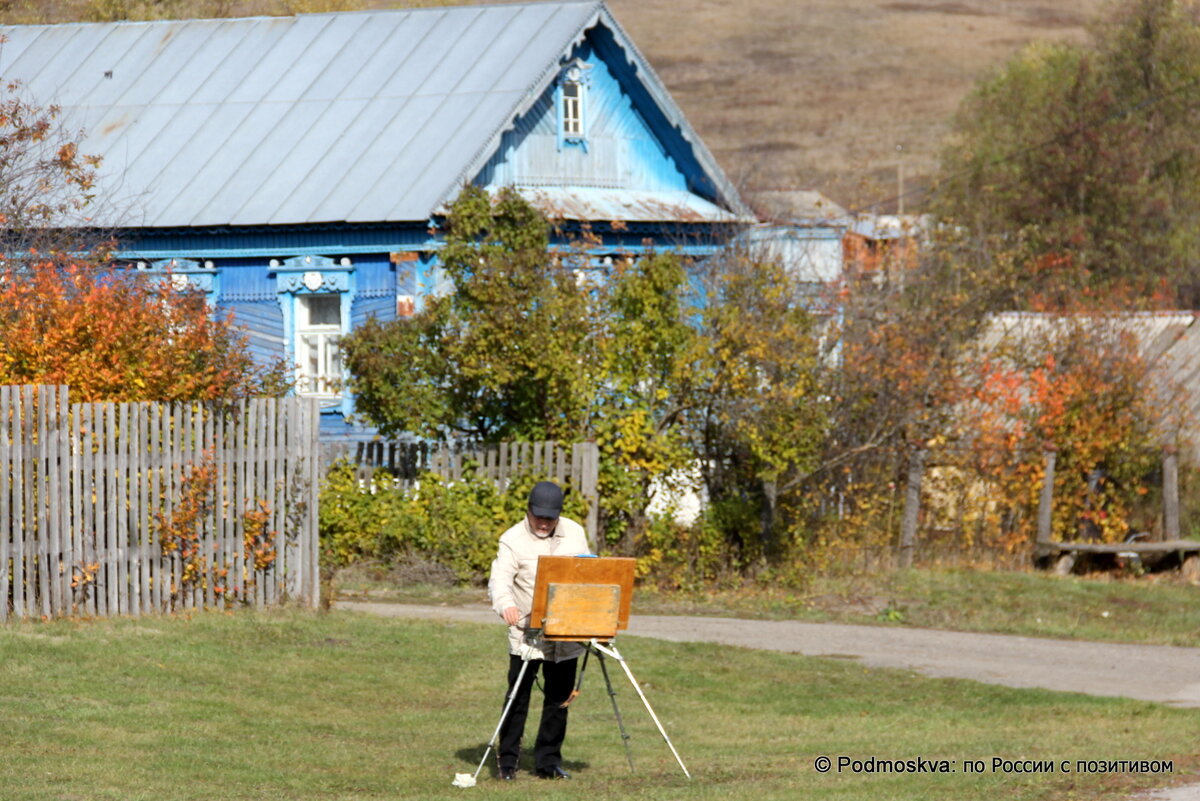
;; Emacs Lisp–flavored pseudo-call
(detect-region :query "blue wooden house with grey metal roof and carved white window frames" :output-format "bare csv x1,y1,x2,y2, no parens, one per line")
0,0,752,434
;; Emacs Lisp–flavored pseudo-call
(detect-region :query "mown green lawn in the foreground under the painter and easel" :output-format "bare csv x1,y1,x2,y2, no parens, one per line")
0,612,1200,801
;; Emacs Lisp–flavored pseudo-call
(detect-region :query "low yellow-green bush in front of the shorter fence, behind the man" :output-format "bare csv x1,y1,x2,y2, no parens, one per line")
320,463,587,583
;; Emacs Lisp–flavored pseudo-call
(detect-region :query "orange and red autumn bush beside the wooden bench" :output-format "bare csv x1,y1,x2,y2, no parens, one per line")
960,327,1160,550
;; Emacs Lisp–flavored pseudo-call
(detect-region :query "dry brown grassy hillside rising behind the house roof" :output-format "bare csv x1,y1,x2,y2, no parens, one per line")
0,0,1120,211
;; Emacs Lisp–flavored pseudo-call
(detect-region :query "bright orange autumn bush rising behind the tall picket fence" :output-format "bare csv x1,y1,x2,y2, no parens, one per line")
0,258,287,402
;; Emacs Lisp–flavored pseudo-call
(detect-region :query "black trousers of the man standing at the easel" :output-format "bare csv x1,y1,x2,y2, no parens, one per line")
497,655,578,770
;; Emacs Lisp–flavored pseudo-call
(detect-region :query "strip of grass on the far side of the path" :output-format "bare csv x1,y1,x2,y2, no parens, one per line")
336,568,1200,646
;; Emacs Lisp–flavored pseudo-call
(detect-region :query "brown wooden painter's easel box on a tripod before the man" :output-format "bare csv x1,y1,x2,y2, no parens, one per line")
529,556,691,778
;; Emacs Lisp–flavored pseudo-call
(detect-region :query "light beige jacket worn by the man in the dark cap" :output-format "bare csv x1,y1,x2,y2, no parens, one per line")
487,517,592,662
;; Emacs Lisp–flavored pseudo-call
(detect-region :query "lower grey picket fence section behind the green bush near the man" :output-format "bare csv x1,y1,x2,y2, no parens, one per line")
322,441,600,543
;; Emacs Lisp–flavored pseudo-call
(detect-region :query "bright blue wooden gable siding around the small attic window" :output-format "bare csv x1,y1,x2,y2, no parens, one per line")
475,29,698,192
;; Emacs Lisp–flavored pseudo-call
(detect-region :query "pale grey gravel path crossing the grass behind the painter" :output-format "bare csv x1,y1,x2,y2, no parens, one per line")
336,601,1200,801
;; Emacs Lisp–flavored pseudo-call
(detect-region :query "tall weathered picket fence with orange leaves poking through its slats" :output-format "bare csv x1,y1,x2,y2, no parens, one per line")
0,386,319,621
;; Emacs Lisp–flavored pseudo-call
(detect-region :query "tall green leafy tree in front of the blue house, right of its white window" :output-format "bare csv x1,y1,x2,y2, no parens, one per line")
341,187,596,441
